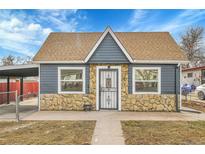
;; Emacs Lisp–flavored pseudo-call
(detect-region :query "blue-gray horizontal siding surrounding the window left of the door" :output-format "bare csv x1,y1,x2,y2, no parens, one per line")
40,64,89,94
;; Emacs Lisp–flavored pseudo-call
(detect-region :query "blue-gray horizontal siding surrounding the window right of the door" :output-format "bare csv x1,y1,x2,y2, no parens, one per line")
128,64,179,94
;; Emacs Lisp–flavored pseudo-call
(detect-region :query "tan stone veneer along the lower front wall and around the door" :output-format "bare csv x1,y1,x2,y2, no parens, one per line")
40,64,176,111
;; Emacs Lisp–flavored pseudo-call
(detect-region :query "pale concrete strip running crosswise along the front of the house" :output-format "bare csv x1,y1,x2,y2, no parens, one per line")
22,111,205,121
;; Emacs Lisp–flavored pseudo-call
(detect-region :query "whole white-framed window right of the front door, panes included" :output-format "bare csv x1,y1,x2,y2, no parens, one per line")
133,67,161,94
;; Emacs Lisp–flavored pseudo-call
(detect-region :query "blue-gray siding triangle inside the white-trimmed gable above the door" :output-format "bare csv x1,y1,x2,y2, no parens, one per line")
88,33,129,63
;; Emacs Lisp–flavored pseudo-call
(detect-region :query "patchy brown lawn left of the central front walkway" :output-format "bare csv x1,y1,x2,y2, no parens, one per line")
0,121,95,144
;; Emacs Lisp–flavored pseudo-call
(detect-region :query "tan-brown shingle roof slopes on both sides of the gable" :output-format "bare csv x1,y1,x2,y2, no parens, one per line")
34,32,187,61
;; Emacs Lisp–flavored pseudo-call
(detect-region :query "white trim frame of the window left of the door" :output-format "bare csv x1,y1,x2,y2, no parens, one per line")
58,67,86,94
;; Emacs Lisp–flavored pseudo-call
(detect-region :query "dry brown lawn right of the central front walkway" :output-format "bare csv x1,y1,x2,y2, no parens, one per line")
121,121,205,145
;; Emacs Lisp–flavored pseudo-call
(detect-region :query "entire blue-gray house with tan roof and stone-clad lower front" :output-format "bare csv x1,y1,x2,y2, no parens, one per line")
33,27,187,111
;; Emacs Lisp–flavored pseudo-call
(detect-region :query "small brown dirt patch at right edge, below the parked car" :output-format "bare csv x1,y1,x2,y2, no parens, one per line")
182,100,205,112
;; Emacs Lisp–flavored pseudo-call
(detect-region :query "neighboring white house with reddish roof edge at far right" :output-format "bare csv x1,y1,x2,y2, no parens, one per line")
182,66,205,86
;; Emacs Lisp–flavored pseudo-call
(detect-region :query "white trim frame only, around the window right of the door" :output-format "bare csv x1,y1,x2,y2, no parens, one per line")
132,67,161,94
